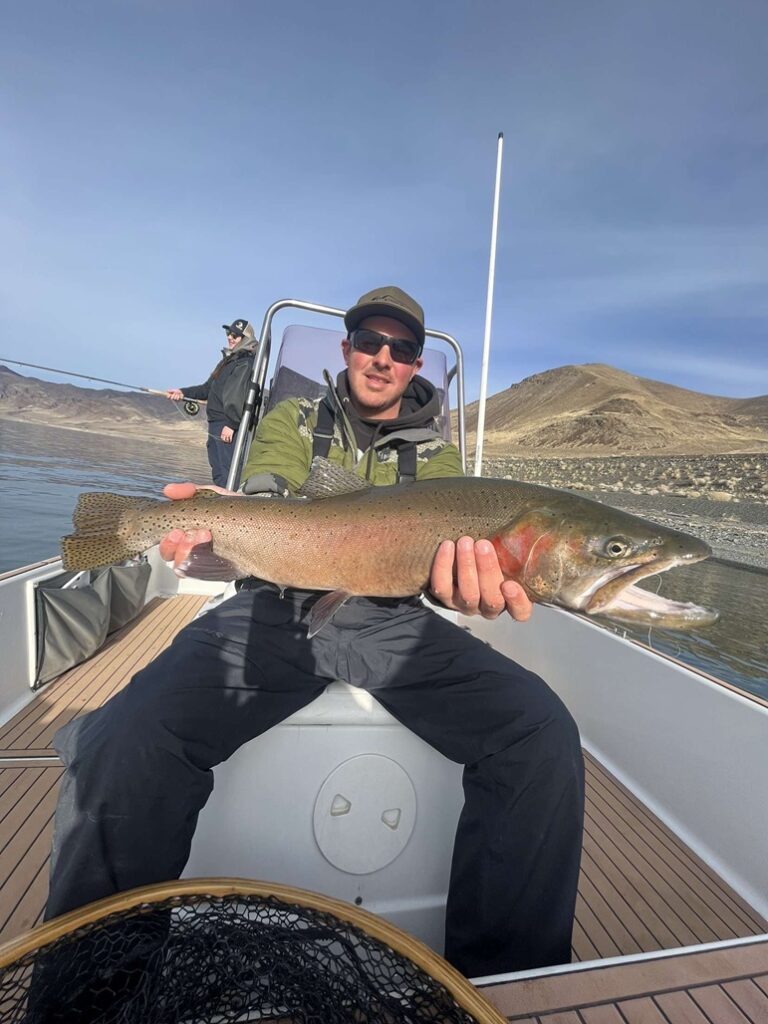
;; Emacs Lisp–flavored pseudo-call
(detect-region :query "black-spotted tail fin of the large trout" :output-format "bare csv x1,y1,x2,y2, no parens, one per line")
61,492,161,571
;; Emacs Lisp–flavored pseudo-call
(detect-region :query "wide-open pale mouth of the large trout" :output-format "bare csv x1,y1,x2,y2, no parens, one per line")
584,552,720,630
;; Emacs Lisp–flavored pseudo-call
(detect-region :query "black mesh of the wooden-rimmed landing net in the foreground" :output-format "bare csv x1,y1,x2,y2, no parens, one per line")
0,894,489,1024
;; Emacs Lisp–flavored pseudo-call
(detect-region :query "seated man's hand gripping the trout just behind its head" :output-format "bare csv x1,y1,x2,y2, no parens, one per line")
429,537,534,623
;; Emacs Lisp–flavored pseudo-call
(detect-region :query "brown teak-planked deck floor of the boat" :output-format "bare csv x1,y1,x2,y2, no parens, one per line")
0,596,768,1024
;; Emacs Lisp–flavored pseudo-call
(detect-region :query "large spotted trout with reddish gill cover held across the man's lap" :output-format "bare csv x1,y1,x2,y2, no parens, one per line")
61,460,718,634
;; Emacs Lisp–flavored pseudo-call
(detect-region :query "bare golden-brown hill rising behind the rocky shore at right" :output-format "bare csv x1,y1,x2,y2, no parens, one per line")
467,364,768,455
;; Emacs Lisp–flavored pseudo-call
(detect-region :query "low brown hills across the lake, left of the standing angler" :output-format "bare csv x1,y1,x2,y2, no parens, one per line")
0,365,206,440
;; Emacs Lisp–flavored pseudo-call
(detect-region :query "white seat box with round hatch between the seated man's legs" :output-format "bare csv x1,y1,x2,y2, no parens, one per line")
184,634,463,951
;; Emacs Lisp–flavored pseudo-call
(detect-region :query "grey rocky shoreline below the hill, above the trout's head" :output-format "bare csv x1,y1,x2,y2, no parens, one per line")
483,454,768,570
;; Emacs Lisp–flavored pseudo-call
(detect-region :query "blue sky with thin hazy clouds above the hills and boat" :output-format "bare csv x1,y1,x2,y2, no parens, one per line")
0,0,768,398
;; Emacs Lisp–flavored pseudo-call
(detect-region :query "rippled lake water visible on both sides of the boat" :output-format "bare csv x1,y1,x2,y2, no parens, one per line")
0,420,768,699
